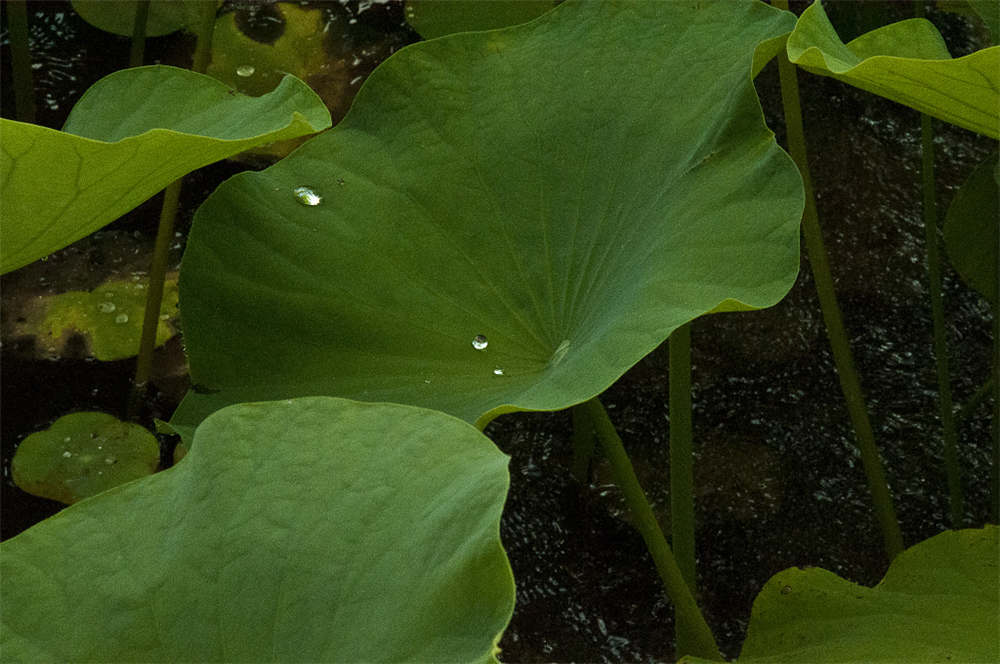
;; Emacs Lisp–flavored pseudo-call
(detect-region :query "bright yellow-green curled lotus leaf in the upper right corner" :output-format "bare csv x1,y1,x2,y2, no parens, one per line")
787,2,1000,138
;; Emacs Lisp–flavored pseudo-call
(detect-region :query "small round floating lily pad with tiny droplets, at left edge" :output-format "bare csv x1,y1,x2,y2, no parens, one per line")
10,413,160,506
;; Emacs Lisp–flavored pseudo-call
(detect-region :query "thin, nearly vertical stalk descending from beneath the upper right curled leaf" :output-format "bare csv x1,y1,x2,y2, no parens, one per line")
917,109,965,528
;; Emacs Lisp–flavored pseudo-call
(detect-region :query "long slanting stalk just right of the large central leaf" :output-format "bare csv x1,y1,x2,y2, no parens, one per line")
774,0,903,560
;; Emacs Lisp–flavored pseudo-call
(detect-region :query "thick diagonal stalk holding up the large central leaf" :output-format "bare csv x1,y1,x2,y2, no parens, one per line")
583,398,722,661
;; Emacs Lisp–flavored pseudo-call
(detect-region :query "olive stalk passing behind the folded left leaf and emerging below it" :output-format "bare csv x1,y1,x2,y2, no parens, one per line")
127,1,216,418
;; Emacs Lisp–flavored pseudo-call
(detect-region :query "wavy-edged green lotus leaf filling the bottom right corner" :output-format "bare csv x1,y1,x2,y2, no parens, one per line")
681,526,1000,664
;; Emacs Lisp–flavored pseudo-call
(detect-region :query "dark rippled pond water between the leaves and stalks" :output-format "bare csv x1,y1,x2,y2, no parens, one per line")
0,2,995,662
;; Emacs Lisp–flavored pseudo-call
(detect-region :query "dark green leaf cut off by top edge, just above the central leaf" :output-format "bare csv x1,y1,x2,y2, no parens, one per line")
406,0,557,39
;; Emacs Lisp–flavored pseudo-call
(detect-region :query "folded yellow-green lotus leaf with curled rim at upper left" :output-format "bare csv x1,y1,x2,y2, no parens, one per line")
0,66,330,272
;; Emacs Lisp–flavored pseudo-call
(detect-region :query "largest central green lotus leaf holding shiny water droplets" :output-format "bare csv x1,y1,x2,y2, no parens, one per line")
172,1,803,436
